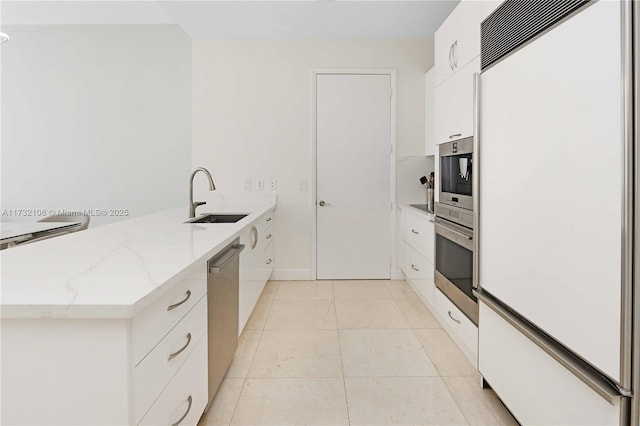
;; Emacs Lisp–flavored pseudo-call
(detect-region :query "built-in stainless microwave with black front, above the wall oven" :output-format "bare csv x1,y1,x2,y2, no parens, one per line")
438,137,473,210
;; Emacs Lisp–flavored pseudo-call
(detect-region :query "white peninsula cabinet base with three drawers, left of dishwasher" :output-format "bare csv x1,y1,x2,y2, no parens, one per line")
2,260,207,425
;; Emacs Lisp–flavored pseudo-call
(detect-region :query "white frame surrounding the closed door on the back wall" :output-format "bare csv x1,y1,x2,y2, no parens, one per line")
309,68,401,281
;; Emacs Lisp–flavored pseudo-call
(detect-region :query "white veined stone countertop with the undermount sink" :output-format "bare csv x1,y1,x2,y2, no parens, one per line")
0,197,276,319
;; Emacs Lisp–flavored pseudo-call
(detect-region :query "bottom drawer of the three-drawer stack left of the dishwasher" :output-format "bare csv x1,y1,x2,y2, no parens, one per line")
139,335,209,426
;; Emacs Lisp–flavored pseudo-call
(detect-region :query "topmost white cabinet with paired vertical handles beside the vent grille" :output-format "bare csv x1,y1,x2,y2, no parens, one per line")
435,0,486,86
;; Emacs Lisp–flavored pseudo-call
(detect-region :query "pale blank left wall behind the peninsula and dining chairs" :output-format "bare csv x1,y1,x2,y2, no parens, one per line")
1,25,191,226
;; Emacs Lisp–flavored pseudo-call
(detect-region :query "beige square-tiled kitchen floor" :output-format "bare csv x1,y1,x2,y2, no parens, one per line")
200,281,517,425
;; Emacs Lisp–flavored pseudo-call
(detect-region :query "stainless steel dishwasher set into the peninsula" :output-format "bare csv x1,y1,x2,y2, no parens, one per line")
207,238,244,410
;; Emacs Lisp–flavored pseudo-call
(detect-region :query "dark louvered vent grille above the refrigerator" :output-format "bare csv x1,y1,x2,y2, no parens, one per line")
481,0,597,70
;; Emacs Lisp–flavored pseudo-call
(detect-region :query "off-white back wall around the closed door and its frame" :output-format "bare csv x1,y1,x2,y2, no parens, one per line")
192,39,433,279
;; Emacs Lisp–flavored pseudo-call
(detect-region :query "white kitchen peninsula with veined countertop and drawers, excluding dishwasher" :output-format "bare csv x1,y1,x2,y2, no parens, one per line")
0,197,276,424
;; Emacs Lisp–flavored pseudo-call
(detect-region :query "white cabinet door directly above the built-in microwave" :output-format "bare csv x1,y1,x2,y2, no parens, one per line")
435,57,480,144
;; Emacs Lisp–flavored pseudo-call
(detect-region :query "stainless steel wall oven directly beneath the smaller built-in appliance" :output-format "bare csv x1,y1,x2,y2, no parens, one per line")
435,203,478,325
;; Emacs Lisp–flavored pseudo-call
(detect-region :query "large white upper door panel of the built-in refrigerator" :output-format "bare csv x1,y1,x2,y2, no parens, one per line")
479,1,623,380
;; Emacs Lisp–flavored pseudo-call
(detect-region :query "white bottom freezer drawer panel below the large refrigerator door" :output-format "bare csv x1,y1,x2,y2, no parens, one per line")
478,302,621,425
